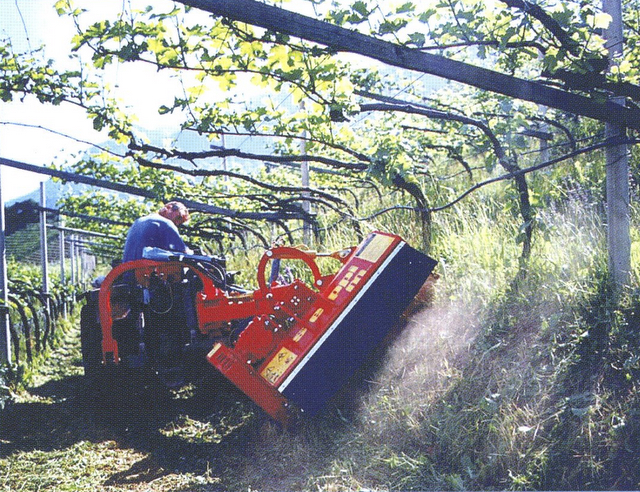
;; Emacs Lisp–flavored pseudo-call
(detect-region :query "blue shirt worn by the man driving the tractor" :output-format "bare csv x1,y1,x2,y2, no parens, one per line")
122,214,187,262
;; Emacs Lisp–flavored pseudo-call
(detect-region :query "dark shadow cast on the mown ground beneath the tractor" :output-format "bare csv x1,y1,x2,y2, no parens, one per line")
0,371,265,486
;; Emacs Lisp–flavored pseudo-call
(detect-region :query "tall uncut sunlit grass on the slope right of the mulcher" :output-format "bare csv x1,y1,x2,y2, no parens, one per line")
224,189,640,490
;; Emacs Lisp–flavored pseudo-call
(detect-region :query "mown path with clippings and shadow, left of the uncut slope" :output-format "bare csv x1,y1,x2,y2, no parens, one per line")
0,324,262,492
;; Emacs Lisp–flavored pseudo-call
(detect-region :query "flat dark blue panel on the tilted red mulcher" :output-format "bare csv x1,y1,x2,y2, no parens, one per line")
280,242,437,414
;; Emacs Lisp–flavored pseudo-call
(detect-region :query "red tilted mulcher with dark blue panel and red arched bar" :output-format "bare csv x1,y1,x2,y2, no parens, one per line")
94,232,436,424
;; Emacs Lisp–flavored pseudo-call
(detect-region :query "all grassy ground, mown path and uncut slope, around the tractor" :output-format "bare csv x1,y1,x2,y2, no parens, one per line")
0,199,640,492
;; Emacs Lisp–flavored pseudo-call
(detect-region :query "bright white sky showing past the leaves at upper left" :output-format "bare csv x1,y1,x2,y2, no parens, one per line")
0,0,185,202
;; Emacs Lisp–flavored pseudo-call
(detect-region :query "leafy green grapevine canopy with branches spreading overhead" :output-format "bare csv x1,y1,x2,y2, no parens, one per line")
0,0,640,257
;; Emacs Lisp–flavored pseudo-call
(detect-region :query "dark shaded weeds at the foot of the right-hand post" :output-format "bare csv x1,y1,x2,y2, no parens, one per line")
541,279,640,489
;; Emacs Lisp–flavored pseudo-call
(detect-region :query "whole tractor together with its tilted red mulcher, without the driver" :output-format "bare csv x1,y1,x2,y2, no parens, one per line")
81,231,436,425
